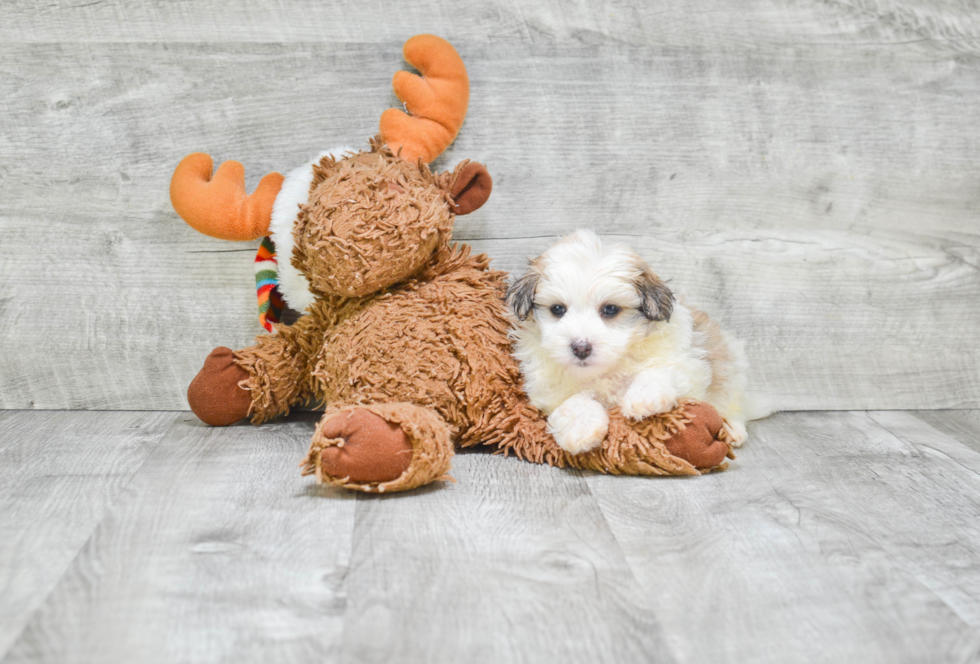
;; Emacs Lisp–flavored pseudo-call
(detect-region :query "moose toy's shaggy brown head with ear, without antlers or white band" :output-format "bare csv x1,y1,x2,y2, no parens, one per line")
292,141,490,297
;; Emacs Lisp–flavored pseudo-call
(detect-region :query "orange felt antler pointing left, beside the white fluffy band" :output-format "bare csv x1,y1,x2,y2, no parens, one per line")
170,152,283,240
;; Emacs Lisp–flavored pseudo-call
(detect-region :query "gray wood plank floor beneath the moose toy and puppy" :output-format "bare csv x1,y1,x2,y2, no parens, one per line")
0,411,980,664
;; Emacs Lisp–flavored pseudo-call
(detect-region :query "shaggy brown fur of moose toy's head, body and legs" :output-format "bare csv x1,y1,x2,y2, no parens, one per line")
207,141,727,492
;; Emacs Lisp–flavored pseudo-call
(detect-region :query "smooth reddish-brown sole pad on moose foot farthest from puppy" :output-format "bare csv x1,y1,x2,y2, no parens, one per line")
319,408,412,484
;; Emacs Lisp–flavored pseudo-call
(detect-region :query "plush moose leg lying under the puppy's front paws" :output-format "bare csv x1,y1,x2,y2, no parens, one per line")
566,400,731,475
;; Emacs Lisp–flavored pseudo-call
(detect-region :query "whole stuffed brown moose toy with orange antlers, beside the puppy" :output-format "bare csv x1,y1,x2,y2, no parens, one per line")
170,35,730,492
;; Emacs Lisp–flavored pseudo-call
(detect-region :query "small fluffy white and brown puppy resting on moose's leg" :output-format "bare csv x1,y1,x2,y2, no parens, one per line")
507,230,748,454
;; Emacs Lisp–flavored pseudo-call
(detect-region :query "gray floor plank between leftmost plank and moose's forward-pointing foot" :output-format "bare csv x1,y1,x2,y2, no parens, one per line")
4,414,354,662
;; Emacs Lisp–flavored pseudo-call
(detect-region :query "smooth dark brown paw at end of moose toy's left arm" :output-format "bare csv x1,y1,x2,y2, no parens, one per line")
187,346,252,427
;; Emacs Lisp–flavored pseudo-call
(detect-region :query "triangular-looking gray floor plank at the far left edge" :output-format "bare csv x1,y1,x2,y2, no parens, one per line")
0,412,177,657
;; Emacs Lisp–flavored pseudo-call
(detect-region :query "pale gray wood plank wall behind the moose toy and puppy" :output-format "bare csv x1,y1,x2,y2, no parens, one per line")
0,0,980,410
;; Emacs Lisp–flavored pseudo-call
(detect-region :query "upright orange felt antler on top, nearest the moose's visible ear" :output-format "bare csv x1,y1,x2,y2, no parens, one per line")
381,35,470,163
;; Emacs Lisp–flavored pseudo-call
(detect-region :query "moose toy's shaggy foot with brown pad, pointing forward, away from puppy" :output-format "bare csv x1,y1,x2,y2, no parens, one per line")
301,403,453,493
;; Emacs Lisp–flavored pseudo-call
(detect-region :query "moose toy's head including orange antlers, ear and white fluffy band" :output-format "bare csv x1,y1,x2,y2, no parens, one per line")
170,35,492,310
